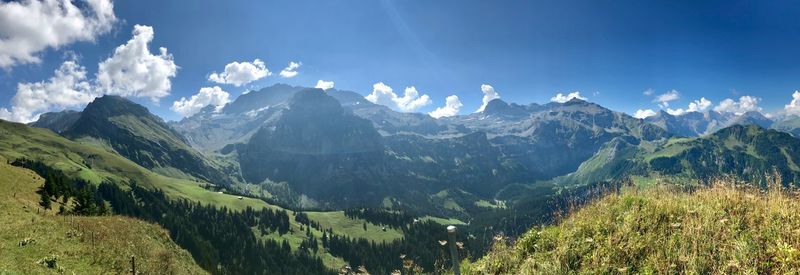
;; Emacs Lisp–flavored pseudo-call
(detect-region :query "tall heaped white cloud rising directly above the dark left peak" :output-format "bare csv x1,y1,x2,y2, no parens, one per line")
97,25,178,101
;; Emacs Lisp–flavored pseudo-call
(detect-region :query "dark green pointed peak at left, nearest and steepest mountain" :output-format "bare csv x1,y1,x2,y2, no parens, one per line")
62,96,231,184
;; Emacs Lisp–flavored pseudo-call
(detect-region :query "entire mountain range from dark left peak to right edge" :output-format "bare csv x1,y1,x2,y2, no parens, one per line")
25,84,800,217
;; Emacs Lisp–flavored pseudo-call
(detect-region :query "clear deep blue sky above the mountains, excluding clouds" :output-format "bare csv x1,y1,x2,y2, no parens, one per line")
0,0,800,120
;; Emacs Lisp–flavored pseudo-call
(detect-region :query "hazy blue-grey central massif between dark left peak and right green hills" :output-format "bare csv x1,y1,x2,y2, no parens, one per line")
172,85,670,209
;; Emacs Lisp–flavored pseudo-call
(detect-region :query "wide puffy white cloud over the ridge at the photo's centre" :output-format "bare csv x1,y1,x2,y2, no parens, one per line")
364,82,431,112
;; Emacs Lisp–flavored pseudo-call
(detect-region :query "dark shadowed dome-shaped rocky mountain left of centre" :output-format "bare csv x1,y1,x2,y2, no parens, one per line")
237,89,386,205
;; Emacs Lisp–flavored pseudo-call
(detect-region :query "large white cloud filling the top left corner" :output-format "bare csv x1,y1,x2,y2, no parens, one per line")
0,0,117,68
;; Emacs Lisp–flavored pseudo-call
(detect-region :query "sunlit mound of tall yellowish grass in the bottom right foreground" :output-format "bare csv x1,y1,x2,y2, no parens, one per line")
465,179,800,274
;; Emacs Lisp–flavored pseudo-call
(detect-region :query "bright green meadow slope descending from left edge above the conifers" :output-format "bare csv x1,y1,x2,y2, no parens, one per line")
0,120,412,268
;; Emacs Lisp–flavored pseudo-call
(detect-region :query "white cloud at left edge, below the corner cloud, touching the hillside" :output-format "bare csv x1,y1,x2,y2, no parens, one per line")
0,60,99,123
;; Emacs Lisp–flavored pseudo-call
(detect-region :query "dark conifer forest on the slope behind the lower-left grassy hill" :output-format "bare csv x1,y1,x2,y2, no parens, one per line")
11,159,334,274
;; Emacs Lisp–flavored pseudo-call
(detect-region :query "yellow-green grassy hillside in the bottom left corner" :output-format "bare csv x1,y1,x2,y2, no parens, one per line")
0,159,205,274
